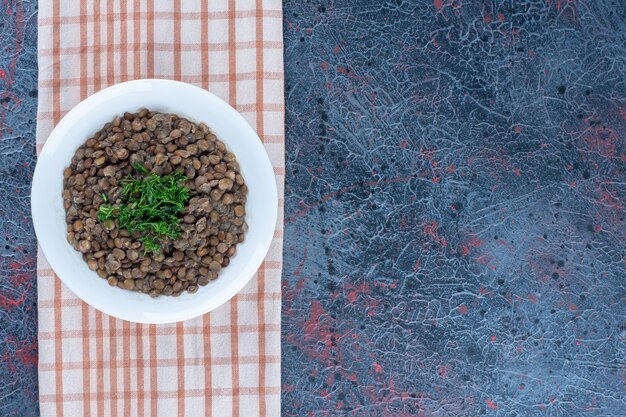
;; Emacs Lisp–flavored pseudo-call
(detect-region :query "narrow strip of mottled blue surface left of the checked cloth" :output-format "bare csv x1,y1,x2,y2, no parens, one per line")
0,0,39,417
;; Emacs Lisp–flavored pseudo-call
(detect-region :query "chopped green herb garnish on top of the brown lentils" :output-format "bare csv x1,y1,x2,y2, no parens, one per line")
97,163,189,253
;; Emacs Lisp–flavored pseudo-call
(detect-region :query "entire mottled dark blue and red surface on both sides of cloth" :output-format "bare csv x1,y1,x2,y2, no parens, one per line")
0,0,626,417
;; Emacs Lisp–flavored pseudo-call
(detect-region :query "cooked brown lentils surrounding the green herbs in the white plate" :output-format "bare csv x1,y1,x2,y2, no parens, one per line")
63,109,248,297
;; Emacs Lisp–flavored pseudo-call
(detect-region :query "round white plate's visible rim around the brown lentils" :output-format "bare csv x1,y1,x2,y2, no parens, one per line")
31,80,278,323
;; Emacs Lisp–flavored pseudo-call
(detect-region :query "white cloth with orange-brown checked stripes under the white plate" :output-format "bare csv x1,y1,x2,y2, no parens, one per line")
37,0,285,417
